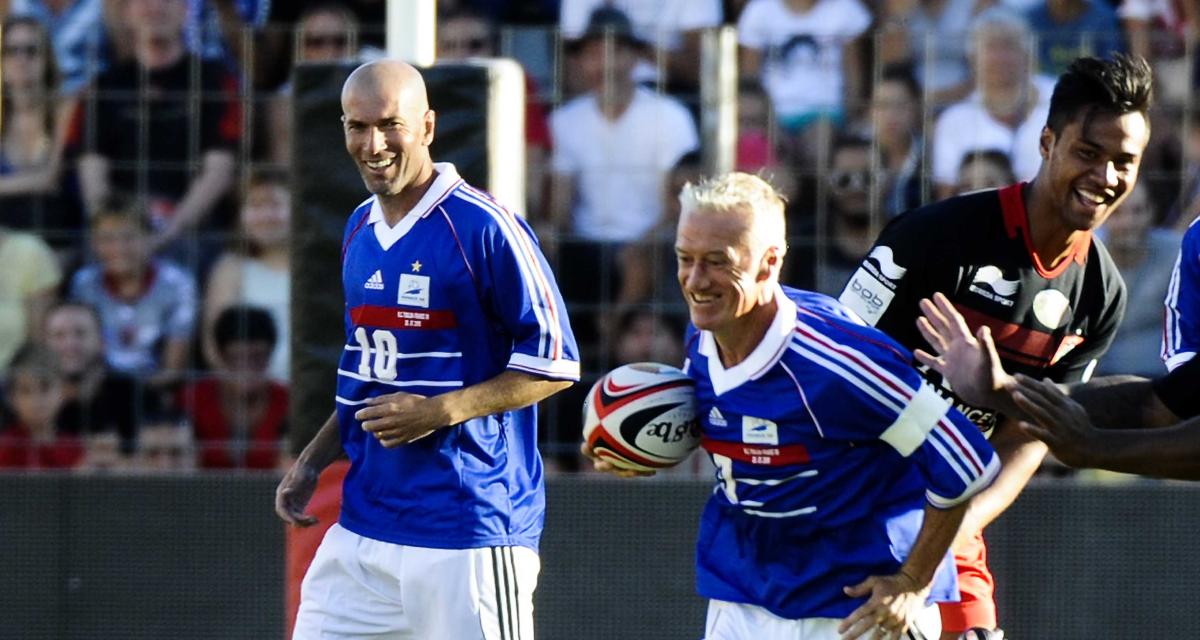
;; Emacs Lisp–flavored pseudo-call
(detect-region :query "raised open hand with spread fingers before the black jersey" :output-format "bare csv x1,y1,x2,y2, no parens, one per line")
913,293,1013,409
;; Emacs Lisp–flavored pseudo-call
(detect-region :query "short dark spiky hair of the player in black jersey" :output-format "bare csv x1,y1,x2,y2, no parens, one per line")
1046,53,1153,136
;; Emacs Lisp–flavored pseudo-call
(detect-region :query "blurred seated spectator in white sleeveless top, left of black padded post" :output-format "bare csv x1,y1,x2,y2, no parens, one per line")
203,169,292,381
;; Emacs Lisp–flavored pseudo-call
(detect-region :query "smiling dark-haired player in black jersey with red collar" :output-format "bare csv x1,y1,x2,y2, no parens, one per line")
840,55,1151,639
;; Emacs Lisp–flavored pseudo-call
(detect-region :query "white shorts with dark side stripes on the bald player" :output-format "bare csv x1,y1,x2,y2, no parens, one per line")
292,524,541,640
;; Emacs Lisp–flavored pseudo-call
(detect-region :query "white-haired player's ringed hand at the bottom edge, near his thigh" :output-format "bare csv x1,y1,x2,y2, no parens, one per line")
838,570,929,640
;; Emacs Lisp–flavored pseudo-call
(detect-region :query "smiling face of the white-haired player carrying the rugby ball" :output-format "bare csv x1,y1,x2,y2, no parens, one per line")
676,209,774,340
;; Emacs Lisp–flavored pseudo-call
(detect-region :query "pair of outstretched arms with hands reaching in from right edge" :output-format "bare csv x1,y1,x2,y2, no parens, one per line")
917,294,1200,480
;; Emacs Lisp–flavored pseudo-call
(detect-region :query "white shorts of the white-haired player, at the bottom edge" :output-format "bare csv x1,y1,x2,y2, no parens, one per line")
704,600,942,640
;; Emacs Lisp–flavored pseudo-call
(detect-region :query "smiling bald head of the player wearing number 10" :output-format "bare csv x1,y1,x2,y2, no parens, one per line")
342,68,434,196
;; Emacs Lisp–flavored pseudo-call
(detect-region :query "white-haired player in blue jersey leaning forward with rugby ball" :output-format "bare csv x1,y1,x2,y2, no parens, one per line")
584,173,1000,640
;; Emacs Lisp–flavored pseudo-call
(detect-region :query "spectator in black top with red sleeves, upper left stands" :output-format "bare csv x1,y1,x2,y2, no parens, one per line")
68,0,242,256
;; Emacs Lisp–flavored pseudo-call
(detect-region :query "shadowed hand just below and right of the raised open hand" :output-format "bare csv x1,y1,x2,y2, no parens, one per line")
1013,373,1103,468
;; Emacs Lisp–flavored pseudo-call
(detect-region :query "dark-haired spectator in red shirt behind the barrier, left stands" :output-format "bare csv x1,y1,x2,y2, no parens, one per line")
179,305,288,469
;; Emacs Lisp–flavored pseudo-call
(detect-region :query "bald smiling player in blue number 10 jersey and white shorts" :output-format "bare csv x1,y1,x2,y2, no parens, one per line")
275,60,580,640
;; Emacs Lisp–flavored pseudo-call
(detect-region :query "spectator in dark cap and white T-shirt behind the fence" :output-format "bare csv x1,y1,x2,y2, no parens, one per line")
542,6,700,353
